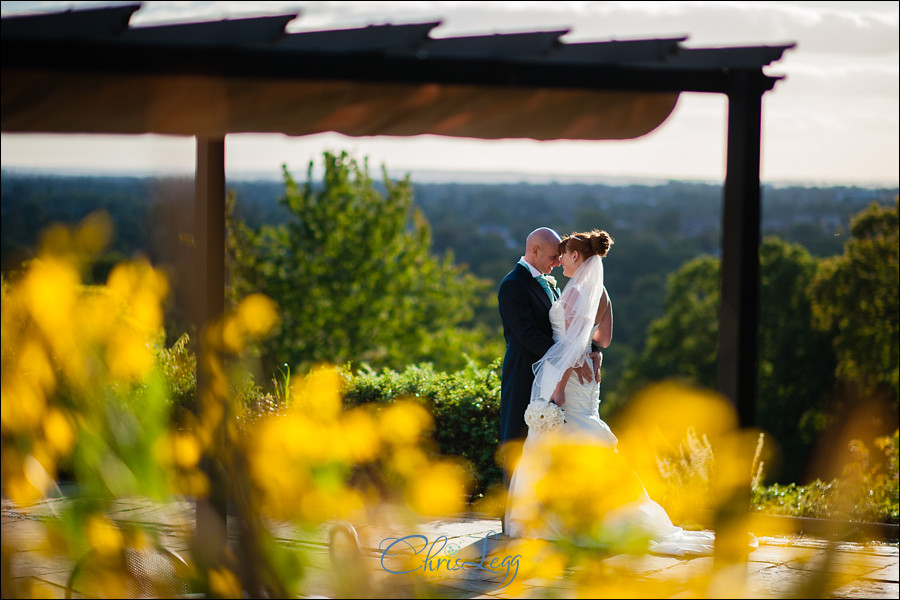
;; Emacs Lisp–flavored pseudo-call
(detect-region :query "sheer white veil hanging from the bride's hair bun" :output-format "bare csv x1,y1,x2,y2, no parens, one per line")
531,254,603,402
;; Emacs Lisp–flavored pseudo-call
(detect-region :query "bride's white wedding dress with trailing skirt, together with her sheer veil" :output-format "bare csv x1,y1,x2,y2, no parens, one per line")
504,256,715,556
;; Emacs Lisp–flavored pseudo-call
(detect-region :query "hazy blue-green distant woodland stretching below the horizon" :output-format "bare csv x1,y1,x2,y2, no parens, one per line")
0,171,898,410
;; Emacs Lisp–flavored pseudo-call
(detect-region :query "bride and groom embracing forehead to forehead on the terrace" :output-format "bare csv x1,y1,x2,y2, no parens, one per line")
498,228,714,556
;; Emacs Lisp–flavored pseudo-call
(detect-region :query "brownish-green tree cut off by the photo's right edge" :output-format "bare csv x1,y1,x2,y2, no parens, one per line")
811,198,900,420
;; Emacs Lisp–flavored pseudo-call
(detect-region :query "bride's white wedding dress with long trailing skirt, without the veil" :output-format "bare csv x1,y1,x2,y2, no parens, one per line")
505,302,715,556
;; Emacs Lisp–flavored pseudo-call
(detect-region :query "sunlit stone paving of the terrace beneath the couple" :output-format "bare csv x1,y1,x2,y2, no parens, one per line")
2,499,900,599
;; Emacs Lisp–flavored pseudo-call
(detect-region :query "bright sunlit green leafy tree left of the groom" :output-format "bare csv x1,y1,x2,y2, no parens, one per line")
229,152,497,376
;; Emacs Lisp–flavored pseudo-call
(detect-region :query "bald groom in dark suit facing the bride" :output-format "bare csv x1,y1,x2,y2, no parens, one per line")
497,227,560,502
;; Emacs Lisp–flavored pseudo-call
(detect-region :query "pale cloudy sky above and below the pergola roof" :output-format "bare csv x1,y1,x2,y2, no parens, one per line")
0,0,900,187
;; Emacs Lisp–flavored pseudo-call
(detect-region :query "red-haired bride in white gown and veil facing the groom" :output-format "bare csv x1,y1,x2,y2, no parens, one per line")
504,230,714,556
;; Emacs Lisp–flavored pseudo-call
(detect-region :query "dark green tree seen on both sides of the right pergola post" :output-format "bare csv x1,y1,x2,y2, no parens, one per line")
613,237,835,481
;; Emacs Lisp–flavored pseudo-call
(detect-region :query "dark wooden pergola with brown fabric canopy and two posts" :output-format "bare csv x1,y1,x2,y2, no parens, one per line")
0,4,794,540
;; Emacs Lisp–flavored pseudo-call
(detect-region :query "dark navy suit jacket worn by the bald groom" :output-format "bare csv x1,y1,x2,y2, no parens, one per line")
497,264,553,445
